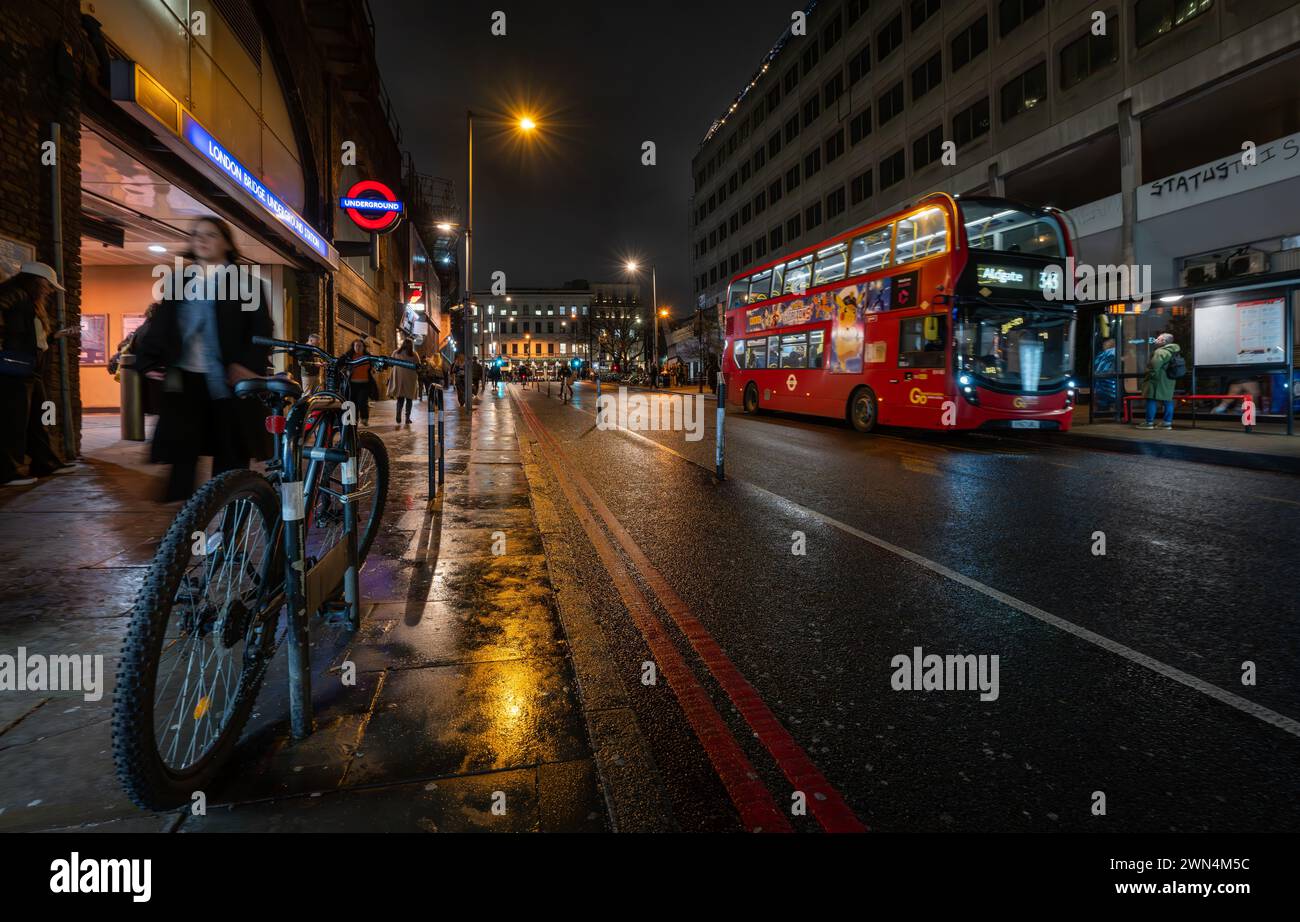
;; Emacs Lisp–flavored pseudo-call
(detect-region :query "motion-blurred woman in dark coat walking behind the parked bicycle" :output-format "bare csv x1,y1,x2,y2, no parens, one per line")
135,217,273,502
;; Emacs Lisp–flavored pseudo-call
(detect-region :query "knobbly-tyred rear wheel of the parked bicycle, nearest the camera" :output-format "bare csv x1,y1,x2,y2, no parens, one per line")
113,471,282,810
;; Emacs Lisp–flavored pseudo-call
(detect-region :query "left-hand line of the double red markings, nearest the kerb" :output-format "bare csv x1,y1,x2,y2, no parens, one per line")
516,398,794,832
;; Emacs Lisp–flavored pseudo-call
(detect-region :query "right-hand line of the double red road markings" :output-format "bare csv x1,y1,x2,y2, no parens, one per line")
516,399,867,832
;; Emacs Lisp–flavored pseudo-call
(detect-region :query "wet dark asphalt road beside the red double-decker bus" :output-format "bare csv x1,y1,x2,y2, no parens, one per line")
506,385,1300,831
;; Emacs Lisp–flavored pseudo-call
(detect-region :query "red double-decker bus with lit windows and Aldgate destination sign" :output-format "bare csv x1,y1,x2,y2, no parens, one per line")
723,194,1075,432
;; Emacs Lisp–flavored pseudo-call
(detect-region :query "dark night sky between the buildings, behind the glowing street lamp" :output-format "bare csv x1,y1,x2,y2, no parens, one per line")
371,0,803,313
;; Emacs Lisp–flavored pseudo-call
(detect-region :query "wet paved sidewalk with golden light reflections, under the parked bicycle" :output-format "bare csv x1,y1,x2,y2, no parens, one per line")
0,398,608,832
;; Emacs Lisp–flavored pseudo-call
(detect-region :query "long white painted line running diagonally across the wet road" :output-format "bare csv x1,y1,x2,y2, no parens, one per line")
546,387,1300,737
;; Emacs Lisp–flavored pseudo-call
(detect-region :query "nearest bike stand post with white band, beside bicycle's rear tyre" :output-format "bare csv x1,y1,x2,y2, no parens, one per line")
280,440,312,740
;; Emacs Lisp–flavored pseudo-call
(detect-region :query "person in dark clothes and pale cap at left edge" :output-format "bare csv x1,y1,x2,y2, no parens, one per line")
0,263,77,486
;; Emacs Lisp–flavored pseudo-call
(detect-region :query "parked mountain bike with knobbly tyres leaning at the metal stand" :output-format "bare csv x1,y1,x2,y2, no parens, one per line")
113,337,416,810
